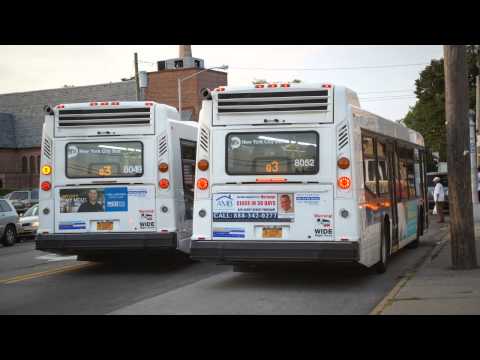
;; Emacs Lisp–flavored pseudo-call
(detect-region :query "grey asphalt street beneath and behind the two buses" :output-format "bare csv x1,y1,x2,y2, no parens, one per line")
0,223,444,314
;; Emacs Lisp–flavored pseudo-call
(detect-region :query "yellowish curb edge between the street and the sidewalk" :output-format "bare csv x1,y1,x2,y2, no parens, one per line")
369,230,449,315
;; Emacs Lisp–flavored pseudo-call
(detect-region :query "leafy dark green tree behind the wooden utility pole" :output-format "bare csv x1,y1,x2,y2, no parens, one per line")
404,45,480,161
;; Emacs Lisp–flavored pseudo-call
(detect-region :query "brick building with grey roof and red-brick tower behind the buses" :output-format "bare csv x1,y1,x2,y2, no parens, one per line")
0,45,227,190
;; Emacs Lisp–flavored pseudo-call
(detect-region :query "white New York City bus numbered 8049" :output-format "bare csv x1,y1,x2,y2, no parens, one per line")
36,101,198,260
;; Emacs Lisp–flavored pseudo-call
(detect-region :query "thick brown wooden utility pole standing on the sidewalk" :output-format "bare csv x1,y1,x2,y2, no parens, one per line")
443,45,477,270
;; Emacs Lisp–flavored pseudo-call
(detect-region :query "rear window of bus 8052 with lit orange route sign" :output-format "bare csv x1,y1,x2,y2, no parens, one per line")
226,131,318,175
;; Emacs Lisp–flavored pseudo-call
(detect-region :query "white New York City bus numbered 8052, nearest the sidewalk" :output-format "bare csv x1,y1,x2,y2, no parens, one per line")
190,84,427,272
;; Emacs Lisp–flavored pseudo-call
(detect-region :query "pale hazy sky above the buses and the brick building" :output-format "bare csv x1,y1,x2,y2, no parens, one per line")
0,45,443,120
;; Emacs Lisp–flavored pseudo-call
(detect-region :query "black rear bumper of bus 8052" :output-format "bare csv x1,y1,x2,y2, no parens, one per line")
190,240,360,264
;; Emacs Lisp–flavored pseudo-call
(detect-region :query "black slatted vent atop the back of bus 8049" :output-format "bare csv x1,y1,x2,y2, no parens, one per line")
58,107,151,128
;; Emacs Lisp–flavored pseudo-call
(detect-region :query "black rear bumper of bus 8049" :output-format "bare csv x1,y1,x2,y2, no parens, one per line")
36,232,177,254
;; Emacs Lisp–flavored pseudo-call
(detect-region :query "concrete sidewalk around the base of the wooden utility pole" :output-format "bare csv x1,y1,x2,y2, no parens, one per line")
380,224,480,315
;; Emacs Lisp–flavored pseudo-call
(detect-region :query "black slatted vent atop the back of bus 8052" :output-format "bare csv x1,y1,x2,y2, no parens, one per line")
218,90,330,114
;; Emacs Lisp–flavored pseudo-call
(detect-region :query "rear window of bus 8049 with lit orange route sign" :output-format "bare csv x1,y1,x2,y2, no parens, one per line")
66,141,143,178
